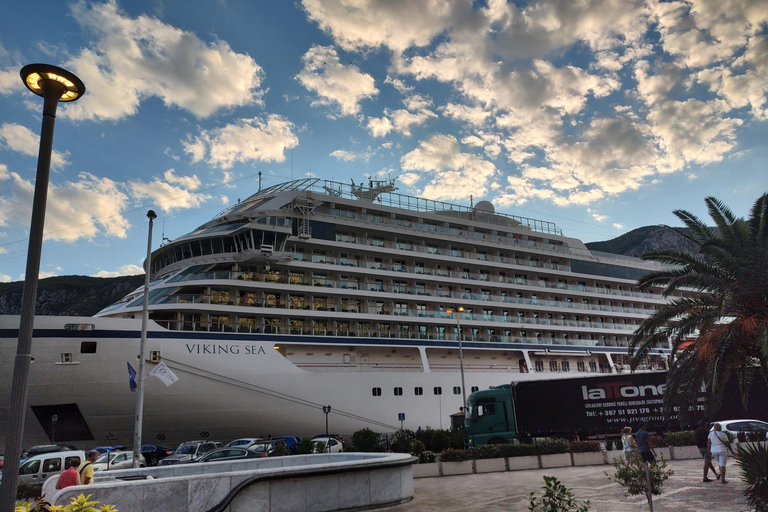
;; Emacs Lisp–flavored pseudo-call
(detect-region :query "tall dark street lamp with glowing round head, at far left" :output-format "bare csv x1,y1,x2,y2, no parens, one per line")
0,64,85,512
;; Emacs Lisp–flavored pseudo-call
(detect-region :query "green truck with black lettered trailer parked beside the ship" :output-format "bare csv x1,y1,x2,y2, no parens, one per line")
464,372,768,447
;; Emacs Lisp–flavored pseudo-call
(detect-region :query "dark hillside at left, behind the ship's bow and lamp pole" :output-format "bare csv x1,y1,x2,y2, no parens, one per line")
0,275,144,316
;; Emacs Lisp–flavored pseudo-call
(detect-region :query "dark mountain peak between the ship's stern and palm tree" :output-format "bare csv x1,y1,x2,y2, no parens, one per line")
585,226,698,258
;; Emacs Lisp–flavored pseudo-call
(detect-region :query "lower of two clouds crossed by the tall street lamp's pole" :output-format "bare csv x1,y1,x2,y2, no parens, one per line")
0,166,131,242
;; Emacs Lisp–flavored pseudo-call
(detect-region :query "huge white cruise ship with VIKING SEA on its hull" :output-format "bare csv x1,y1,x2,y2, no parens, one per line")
0,178,670,446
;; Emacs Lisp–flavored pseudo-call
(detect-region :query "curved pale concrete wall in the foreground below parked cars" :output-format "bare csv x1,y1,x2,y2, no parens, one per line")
51,453,416,512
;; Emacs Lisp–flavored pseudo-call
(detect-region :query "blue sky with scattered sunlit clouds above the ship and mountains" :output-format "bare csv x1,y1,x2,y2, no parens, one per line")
0,0,768,282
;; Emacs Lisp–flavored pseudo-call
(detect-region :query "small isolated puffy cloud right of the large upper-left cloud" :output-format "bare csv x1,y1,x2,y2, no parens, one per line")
296,46,379,116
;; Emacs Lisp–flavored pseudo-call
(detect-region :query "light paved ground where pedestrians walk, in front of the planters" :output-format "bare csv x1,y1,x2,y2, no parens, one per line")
386,460,750,512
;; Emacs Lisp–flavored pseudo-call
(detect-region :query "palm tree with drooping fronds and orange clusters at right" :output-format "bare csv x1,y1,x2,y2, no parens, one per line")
629,194,768,410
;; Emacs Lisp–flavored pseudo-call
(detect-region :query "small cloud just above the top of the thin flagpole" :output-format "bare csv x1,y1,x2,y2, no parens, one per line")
128,169,212,213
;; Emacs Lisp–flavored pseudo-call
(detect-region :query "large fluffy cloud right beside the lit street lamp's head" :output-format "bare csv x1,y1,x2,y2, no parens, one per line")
60,0,264,119
